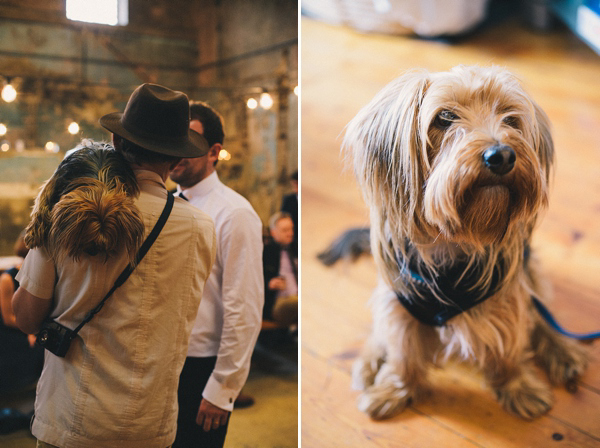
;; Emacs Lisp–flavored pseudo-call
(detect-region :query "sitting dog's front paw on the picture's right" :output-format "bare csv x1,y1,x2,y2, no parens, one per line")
496,374,554,420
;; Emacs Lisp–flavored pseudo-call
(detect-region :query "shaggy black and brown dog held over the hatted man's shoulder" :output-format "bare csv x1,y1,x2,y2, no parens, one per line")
25,140,144,261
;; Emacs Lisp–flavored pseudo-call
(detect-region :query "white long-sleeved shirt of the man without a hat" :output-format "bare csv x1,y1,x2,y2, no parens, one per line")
178,172,264,411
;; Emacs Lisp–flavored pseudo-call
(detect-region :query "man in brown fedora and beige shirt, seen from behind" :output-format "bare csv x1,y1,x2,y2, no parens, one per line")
13,84,216,448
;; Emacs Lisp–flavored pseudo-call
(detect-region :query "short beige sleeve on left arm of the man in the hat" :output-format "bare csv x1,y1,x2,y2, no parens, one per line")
16,247,56,299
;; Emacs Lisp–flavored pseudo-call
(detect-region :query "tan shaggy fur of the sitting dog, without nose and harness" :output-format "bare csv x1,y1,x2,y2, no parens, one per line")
344,66,587,419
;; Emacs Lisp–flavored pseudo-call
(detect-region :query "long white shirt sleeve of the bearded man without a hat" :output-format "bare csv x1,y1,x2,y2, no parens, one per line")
202,209,264,411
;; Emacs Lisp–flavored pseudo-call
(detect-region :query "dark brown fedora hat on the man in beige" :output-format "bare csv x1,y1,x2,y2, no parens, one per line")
100,84,208,157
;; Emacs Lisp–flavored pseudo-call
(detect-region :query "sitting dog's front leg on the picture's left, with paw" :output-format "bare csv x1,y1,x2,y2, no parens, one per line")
353,285,437,419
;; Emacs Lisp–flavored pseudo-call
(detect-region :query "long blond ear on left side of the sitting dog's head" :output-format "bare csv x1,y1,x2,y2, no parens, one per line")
343,71,430,256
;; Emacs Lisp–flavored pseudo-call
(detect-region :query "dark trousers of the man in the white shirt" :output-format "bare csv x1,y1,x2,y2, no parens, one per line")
173,356,229,448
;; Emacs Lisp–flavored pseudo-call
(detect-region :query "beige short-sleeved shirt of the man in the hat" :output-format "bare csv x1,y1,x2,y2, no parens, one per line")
17,170,216,448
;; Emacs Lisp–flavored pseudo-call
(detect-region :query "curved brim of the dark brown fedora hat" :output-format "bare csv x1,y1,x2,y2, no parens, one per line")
100,112,209,158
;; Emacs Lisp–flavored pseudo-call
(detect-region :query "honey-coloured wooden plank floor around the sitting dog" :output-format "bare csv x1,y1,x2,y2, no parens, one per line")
301,14,600,447
